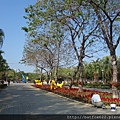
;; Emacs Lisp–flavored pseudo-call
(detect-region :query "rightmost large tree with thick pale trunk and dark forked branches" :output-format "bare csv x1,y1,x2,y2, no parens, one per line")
89,0,120,98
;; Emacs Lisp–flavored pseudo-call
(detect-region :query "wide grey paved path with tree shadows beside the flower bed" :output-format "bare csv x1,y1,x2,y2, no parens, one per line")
0,83,120,118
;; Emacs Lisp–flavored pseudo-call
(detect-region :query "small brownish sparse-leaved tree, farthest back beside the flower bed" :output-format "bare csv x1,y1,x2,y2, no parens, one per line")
21,40,49,78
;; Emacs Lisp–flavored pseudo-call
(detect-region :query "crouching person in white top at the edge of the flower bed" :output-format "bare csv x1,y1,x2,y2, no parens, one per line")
91,93,106,109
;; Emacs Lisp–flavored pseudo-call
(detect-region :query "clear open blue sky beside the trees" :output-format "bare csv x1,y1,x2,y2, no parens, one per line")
0,0,120,72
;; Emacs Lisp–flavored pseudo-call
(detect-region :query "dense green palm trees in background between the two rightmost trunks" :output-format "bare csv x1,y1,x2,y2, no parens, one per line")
83,56,113,83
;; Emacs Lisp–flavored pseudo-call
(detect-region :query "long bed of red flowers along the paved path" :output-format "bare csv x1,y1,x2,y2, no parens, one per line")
32,85,120,106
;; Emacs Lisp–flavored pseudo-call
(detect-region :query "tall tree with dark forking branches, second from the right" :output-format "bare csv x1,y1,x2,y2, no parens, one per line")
47,0,103,85
